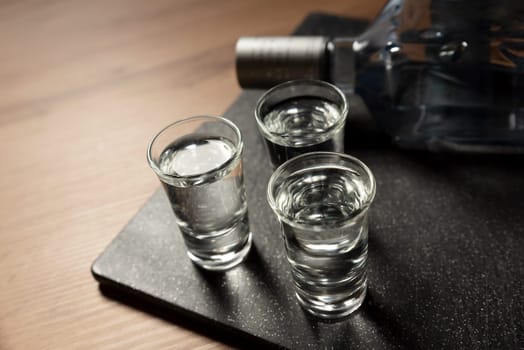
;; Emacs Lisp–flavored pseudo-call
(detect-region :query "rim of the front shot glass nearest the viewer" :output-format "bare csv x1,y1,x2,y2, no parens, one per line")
266,152,377,231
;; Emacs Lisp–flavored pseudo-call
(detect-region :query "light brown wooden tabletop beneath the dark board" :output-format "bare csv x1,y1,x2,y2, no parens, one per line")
0,0,384,349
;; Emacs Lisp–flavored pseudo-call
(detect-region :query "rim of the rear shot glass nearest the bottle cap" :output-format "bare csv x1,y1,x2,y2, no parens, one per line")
255,79,349,146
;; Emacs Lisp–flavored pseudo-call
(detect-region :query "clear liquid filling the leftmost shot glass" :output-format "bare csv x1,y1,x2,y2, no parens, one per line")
159,137,251,269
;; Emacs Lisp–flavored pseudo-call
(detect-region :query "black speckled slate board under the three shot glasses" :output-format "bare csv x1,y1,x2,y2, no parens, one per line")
92,14,524,349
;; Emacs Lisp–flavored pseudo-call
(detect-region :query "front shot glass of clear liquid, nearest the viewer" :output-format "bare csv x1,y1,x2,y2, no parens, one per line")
267,152,376,319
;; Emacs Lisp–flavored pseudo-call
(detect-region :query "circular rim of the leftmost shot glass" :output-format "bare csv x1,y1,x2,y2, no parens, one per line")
147,115,244,185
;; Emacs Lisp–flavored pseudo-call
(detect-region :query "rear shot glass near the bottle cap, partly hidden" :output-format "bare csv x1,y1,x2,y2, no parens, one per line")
255,80,348,168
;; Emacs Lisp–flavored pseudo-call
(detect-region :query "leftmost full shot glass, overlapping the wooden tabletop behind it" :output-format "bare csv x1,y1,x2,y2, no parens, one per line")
147,116,251,270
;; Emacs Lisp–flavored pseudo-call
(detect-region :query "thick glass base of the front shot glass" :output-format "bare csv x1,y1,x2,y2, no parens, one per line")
296,283,367,319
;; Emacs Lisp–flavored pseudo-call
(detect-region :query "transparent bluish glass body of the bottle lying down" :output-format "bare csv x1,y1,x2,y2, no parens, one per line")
352,0,524,152
